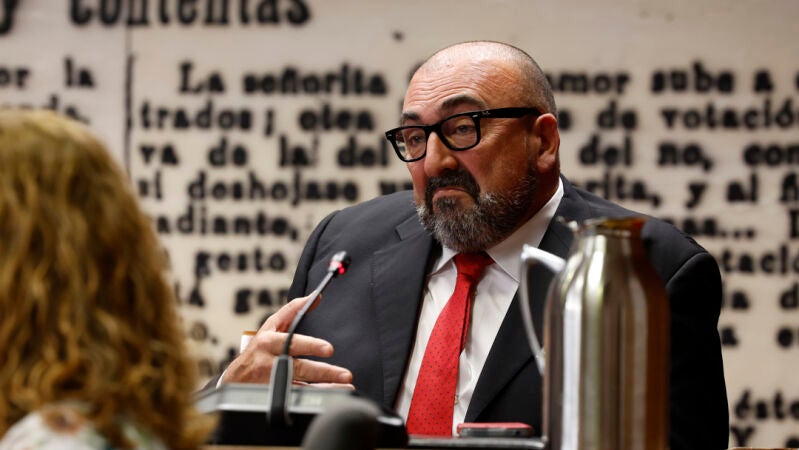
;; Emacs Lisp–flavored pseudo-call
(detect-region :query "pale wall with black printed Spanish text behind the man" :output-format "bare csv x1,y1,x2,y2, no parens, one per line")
0,0,799,447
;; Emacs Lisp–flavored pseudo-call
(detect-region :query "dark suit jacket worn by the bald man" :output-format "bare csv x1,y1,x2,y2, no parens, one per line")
289,179,729,450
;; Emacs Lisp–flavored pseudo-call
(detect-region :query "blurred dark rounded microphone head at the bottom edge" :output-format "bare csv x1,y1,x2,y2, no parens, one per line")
302,397,381,450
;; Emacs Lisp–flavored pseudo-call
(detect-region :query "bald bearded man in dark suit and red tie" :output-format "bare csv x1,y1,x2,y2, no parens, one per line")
221,42,729,450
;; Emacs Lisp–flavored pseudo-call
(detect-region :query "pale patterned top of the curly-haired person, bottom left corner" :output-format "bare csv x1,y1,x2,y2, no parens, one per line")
0,403,166,450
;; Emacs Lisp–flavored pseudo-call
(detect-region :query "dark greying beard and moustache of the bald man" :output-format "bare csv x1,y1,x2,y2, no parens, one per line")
416,164,536,253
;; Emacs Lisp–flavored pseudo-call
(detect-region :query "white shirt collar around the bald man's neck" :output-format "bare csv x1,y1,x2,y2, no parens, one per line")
432,177,563,282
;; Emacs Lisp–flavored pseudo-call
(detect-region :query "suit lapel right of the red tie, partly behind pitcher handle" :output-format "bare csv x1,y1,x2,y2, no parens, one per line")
466,180,587,421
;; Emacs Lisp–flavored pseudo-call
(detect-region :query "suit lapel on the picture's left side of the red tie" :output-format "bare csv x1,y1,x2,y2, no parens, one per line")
372,214,433,408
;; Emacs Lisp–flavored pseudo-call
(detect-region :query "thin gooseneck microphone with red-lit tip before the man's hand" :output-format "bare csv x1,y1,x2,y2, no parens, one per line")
267,251,350,427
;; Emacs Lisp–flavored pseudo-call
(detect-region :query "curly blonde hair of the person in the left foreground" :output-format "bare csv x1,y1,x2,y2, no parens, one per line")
0,110,212,449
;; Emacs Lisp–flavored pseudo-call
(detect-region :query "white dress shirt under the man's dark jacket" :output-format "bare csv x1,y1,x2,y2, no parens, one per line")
397,180,563,434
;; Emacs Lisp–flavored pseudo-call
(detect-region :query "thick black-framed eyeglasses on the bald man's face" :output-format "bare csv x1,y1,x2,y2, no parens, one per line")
386,107,543,162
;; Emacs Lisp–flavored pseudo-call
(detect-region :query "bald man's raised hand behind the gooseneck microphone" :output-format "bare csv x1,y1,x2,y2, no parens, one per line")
222,295,352,385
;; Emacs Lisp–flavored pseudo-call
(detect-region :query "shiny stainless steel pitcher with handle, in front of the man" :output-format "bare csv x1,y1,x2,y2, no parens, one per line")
519,217,669,450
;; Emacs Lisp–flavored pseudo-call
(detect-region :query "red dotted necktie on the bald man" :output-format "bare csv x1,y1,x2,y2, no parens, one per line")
406,253,494,436
